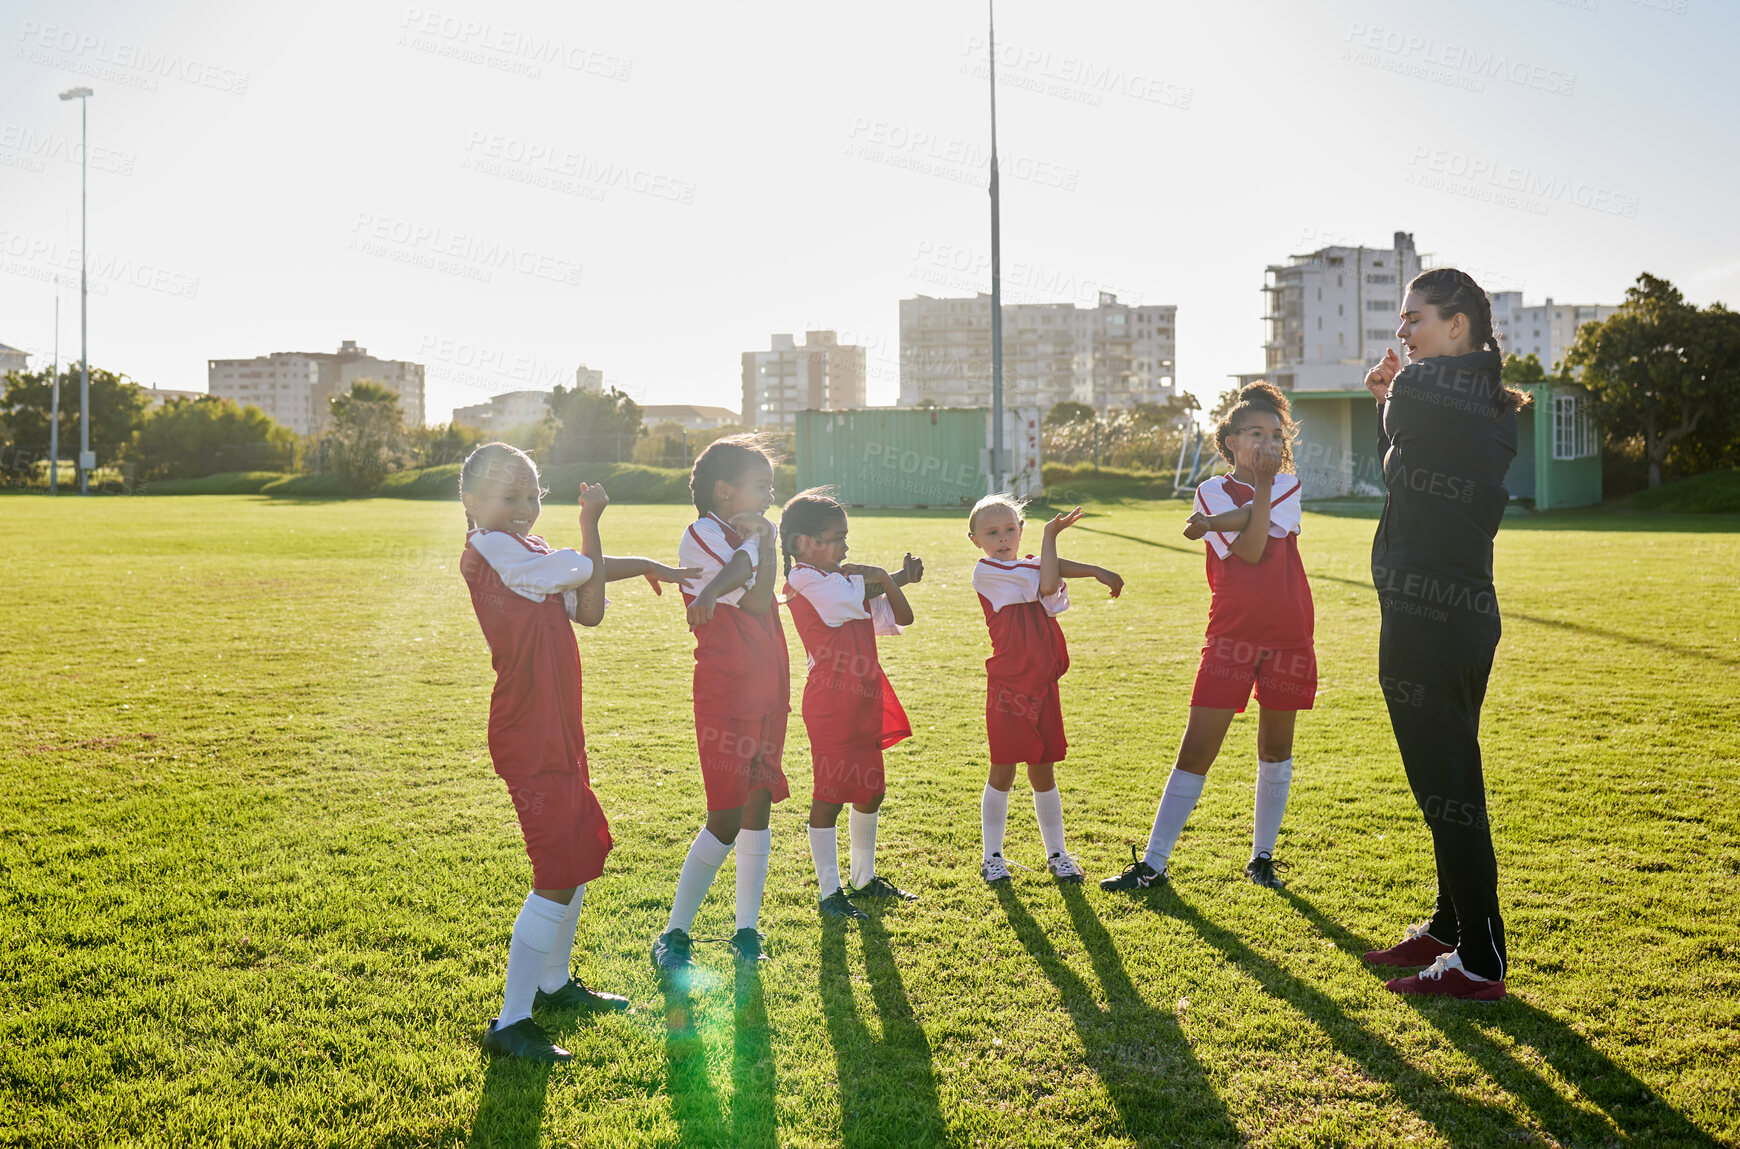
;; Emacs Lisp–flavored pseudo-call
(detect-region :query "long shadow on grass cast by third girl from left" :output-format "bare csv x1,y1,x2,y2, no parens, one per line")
821,919,943,1146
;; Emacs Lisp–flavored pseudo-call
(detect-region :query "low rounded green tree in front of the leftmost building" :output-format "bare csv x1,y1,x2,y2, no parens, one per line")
139,395,296,479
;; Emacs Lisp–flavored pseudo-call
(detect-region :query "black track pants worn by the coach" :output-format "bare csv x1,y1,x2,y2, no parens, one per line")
1378,594,1507,978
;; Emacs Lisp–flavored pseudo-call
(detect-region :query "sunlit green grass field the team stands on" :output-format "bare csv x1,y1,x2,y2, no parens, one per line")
0,496,1740,1149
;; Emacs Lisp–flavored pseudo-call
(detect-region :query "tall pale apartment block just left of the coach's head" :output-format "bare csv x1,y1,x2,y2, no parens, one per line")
1266,232,1420,392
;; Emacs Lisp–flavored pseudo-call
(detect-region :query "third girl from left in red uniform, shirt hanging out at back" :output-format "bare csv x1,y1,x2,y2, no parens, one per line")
780,491,924,917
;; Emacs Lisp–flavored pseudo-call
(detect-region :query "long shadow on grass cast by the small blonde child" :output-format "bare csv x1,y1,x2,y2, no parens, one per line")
995,883,1239,1144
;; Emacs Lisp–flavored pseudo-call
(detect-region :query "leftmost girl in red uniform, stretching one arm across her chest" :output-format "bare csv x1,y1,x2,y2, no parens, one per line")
459,442,699,1062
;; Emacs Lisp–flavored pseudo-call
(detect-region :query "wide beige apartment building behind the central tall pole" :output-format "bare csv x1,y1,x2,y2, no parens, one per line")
900,292,1178,413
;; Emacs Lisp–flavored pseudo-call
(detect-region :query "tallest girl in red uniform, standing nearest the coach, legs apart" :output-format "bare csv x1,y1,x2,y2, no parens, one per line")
1100,383,1317,890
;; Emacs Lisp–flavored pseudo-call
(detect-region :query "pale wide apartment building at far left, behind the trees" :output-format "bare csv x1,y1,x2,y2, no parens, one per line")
205,339,423,435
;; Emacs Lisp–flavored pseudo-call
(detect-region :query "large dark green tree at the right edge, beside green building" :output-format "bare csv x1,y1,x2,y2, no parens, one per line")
1564,272,1740,487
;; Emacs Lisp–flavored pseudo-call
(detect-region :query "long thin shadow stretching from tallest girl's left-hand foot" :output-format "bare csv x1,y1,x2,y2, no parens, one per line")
1147,890,1535,1146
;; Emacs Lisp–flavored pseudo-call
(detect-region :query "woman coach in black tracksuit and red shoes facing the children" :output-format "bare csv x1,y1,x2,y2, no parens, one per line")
1366,268,1526,1001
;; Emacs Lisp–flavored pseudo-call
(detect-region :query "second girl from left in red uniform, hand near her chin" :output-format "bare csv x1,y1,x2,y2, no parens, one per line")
653,437,792,977
